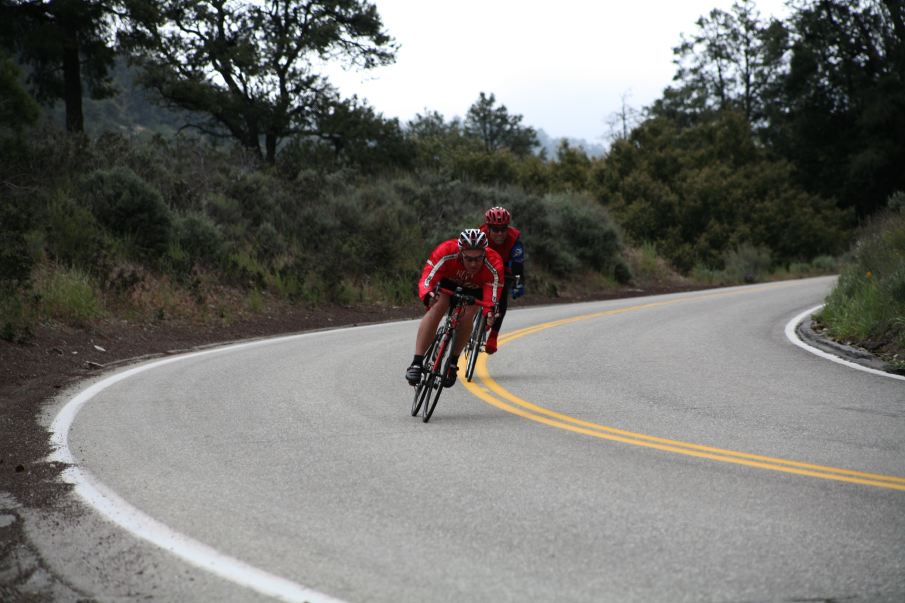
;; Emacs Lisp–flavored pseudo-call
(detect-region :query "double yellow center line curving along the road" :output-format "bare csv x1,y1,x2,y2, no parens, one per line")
463,291,905,491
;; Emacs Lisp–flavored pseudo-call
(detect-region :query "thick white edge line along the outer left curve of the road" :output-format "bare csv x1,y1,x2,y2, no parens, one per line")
48,323,396,603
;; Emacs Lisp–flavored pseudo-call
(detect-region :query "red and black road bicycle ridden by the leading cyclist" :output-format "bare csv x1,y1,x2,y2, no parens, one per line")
412,287,491,423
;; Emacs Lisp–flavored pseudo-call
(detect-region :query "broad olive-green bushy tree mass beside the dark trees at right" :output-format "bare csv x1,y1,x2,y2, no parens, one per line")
593,111,848,272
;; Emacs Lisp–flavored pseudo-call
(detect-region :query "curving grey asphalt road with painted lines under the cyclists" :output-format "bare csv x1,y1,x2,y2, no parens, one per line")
40,278,905,602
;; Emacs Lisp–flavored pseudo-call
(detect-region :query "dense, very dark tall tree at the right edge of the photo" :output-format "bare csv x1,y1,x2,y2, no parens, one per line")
772,0,905,216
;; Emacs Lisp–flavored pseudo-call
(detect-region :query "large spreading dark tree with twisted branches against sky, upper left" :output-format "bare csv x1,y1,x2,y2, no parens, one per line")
122,0,395,162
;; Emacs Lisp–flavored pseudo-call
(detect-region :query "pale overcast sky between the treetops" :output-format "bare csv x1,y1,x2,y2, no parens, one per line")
329,0,787,143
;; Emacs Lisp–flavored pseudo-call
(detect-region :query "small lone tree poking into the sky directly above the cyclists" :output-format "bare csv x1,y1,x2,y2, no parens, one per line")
465,92,540,156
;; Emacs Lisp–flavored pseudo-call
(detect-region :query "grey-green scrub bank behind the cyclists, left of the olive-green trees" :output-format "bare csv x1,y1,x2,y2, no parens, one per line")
2,132,628,337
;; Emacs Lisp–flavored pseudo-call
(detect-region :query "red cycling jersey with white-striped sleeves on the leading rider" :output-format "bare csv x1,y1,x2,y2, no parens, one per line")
418,239,503,304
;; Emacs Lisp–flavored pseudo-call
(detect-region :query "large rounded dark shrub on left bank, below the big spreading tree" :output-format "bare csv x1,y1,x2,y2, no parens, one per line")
79,167,173,257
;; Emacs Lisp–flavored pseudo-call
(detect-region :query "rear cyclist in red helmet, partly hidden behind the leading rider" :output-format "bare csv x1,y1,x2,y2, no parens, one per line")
481,207,525,354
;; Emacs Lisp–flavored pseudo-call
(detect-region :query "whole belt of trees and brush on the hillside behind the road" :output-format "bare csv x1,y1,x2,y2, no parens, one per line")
0,0,905,354
